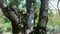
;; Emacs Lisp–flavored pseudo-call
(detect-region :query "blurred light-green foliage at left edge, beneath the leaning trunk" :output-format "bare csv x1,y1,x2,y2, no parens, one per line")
0,10,12,32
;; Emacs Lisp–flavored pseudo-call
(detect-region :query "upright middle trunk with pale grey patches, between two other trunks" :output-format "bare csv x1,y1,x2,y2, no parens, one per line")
25,0,36,34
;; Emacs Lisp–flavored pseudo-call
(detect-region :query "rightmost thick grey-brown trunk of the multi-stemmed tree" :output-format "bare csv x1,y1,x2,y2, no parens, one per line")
36,0,48,34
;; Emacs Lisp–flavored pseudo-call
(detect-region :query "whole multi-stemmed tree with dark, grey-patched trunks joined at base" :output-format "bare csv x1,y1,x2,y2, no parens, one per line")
0,0,48,34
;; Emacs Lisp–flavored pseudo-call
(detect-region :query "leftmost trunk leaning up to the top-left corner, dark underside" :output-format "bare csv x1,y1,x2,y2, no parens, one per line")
0,0,22,34
